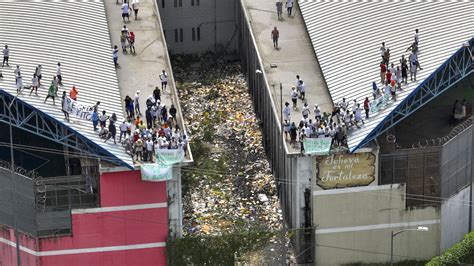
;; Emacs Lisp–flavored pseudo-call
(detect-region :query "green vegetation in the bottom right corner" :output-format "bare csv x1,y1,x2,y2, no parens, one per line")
426,232,474,266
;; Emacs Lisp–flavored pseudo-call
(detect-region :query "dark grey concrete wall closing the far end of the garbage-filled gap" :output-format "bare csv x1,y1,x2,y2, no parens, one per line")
156,0,237,54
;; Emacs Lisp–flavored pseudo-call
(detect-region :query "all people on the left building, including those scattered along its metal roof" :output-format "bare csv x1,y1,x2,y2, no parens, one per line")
0,6,188,165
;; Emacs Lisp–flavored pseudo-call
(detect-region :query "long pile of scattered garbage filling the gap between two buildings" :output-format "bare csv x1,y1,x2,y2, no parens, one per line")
174,61,283,235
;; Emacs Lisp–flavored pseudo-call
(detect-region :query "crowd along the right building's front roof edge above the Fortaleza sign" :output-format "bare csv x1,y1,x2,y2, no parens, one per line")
282,29,422,150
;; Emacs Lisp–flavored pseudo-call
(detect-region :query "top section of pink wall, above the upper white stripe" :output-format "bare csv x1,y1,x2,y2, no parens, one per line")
100,171,167,207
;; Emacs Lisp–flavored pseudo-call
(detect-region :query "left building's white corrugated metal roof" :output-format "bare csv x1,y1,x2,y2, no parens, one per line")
0,0,133,167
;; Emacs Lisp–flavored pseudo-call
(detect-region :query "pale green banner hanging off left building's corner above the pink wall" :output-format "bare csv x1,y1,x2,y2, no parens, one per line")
141,149,184,182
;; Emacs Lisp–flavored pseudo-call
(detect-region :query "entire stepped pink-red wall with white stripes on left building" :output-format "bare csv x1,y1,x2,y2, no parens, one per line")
0,171,168,266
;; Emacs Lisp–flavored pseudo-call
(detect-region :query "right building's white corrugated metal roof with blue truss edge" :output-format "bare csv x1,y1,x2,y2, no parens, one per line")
299,0,474,153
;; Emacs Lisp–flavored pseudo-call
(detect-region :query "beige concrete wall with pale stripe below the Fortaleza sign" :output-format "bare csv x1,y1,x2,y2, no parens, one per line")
313,184,440,265
